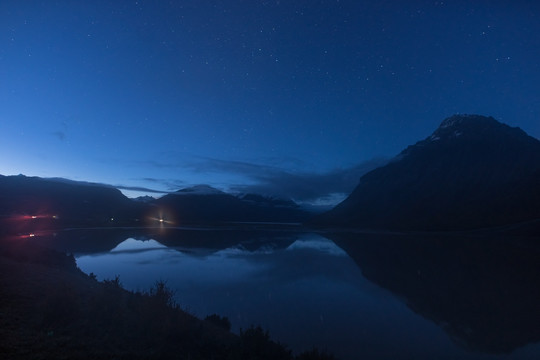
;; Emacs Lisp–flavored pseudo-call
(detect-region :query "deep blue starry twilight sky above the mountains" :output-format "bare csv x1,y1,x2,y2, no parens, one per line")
0,0,540,204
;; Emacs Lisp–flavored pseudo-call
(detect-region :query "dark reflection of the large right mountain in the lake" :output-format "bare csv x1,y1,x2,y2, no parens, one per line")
327,233,540,354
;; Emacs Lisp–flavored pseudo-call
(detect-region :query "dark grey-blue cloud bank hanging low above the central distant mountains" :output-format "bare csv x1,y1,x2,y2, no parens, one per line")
103,157,388,205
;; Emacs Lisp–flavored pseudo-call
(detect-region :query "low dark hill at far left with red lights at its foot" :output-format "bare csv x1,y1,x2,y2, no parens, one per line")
0,175,143,233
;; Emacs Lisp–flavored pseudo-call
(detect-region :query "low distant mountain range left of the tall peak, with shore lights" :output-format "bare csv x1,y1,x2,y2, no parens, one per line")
0,175,312,234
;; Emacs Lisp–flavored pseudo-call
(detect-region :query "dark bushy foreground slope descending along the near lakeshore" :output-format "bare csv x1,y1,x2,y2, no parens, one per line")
0,238,334,360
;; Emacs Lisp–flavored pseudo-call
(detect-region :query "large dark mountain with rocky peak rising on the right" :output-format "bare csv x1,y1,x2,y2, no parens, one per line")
316,115,540,230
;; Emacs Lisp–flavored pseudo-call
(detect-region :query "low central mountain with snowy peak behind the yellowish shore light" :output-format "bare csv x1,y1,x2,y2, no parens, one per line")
153,185,311,224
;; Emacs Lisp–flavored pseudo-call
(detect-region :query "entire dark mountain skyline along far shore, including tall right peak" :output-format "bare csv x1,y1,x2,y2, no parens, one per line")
0,115,540,231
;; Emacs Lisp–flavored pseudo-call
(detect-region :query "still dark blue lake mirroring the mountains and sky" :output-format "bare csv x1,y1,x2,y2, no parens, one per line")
40,229,540,359
